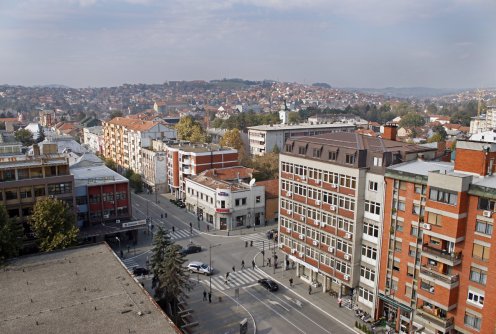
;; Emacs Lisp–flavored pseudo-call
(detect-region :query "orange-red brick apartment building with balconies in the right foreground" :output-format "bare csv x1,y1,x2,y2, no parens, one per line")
376,141,496,334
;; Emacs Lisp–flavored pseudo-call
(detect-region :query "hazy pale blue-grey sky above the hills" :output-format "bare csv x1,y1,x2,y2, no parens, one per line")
0,0,496,88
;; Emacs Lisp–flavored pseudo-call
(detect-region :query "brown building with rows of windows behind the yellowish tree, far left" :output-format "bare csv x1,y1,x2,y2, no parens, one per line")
0,144,75,239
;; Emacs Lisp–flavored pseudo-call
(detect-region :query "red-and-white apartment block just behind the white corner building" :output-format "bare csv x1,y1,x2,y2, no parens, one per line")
152,140,239,200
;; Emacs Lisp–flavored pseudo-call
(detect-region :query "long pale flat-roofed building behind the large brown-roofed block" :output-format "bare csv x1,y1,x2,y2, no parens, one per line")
248,123,356,155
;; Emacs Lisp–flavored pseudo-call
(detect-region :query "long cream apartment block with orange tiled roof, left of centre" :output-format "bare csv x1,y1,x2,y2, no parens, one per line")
102,117,176,174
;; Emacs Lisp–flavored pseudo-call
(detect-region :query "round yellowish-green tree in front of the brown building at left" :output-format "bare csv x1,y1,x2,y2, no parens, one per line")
29,198,79,251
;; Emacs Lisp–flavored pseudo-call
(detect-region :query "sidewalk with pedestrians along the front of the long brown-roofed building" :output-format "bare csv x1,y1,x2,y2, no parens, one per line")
255,250,363,334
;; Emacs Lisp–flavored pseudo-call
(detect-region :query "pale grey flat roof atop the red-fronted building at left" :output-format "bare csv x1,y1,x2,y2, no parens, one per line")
70,165,127,187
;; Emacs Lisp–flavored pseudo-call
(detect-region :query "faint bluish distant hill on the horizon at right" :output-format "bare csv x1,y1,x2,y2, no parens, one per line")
344,87,466,98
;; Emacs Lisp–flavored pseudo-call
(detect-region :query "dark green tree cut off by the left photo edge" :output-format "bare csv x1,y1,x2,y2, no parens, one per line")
0,205,23,264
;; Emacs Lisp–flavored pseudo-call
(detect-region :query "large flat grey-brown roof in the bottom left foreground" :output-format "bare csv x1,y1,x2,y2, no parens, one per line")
0,243,180,334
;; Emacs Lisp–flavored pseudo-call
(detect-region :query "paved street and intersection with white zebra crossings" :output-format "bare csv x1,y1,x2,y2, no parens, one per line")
123,194,356,333
